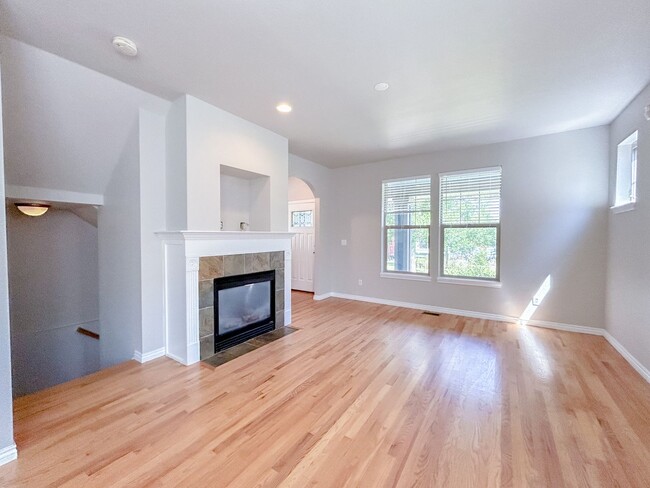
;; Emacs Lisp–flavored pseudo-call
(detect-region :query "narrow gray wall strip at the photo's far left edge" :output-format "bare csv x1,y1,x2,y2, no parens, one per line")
0,63,14,464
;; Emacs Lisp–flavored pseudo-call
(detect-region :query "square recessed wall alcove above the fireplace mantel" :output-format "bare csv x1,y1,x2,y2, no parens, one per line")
220,164,271,231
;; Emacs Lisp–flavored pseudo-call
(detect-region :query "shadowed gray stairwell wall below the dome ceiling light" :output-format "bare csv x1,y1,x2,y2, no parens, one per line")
7,206,99,396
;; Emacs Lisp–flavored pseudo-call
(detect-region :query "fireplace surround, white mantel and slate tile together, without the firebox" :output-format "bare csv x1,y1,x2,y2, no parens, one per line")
158,231,293,365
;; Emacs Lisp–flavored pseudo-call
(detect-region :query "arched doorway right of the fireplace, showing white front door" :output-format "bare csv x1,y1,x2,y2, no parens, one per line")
288,176,320,293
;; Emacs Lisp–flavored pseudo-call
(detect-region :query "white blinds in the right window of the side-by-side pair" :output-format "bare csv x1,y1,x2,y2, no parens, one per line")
440,167,501,226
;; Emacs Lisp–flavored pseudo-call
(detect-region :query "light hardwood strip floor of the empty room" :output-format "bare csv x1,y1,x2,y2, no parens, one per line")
0,293,650,487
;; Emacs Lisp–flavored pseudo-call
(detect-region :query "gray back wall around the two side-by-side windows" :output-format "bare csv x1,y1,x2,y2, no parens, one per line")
331,127,608,327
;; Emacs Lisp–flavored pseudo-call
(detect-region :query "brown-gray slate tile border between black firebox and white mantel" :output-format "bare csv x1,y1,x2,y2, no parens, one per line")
199,251,284,359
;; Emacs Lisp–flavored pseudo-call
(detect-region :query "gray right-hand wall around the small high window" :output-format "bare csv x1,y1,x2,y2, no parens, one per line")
607,85,650,369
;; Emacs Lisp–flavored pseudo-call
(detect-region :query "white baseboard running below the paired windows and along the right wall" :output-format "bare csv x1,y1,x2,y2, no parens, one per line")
314,292,650,383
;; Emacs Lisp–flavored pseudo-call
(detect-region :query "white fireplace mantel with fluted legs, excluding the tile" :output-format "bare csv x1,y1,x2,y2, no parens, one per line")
157,230,293,365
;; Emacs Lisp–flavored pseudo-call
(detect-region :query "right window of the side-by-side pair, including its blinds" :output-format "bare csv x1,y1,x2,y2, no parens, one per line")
440,167,501,281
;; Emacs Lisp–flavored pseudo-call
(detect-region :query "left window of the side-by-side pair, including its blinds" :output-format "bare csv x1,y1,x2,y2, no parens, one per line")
382,176,431,275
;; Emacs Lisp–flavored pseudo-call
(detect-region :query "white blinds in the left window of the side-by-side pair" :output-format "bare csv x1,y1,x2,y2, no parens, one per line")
383,176,431,225
